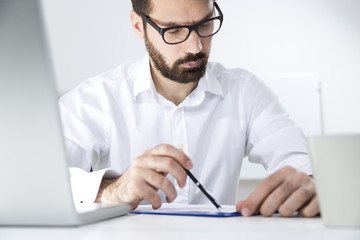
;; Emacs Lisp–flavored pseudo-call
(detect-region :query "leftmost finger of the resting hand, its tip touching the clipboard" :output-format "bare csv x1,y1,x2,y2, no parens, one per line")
241,167,296,216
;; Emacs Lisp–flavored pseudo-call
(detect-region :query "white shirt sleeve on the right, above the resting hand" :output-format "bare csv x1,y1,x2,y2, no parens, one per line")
243,74,312,175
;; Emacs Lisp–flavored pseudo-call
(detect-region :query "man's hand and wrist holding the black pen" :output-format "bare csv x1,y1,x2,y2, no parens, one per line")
96,144,193,209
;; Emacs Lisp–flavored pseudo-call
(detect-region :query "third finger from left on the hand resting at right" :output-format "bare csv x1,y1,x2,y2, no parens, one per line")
279,182,315,216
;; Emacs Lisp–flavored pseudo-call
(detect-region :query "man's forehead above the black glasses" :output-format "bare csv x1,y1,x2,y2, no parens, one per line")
150,0,214,24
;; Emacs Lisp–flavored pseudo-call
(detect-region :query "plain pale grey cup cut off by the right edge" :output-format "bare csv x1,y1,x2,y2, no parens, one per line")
308,134,360,228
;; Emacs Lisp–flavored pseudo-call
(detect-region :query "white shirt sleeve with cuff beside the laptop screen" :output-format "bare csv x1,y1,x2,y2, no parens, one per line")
59,82,116,203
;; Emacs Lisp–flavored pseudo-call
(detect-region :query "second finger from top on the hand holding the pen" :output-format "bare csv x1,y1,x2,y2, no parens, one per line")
136,155,187,187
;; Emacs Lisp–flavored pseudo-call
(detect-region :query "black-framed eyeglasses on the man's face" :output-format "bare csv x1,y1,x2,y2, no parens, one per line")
141,2,224,44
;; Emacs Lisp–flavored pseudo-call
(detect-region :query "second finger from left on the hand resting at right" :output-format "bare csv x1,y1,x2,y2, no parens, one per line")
259,176,301,217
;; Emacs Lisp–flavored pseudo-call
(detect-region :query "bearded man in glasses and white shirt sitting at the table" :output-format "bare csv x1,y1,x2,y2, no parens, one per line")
60,0,319,217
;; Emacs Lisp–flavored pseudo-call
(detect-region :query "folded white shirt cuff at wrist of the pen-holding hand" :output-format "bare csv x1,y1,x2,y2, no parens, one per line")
69,167,120,203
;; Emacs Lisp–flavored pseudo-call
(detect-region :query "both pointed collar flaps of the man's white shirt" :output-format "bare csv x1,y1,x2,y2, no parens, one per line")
133,54,224,102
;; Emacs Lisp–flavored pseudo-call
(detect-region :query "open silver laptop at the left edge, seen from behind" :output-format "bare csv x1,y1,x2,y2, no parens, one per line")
0,0,130,226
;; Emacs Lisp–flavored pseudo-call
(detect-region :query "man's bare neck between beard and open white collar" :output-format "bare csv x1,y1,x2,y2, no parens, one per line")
150,60,198,106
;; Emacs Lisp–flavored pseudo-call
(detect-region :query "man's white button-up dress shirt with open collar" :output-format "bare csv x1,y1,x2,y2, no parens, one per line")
59,55,312,204
